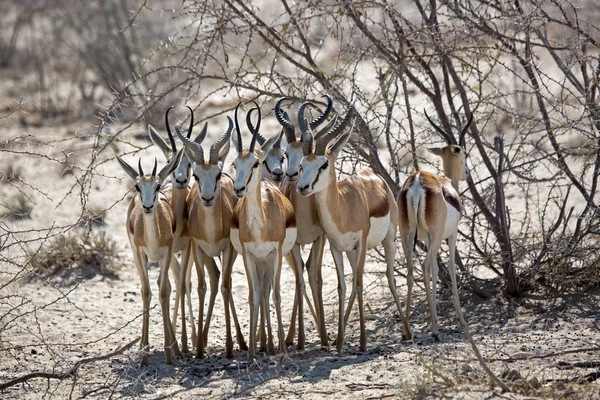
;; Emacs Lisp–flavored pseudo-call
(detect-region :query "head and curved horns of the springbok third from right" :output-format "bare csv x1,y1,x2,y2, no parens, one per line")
275,94,337,182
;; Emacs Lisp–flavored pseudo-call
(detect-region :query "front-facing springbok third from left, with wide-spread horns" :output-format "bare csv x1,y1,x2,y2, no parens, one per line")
175,117,248,358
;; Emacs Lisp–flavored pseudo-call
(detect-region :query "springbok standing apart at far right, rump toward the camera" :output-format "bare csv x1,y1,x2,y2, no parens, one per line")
398,113,473,341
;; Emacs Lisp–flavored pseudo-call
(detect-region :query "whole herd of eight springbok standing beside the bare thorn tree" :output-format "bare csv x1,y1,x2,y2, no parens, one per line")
117,95,472,365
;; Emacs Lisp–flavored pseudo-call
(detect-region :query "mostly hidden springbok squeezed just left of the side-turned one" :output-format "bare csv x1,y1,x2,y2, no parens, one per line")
275,95,337,349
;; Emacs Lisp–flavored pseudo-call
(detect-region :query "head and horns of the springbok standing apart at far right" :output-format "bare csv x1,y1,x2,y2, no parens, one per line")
425,112,473,181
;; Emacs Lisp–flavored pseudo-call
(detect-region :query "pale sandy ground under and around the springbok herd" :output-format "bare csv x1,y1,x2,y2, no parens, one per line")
0,114,600,399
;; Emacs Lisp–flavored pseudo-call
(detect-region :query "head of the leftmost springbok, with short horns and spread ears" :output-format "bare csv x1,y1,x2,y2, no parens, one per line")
115,150,183,214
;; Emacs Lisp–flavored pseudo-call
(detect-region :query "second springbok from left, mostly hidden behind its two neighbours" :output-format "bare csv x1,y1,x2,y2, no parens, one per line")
148,106,207,353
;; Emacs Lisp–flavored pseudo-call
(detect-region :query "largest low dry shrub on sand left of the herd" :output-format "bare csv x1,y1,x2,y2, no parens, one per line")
30,231,123,286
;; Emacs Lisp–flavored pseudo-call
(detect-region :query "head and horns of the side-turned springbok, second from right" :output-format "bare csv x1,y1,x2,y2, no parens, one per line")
297,102,354,196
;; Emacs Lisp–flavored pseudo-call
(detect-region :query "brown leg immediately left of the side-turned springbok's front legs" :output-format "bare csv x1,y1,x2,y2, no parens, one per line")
306,235,329,347
